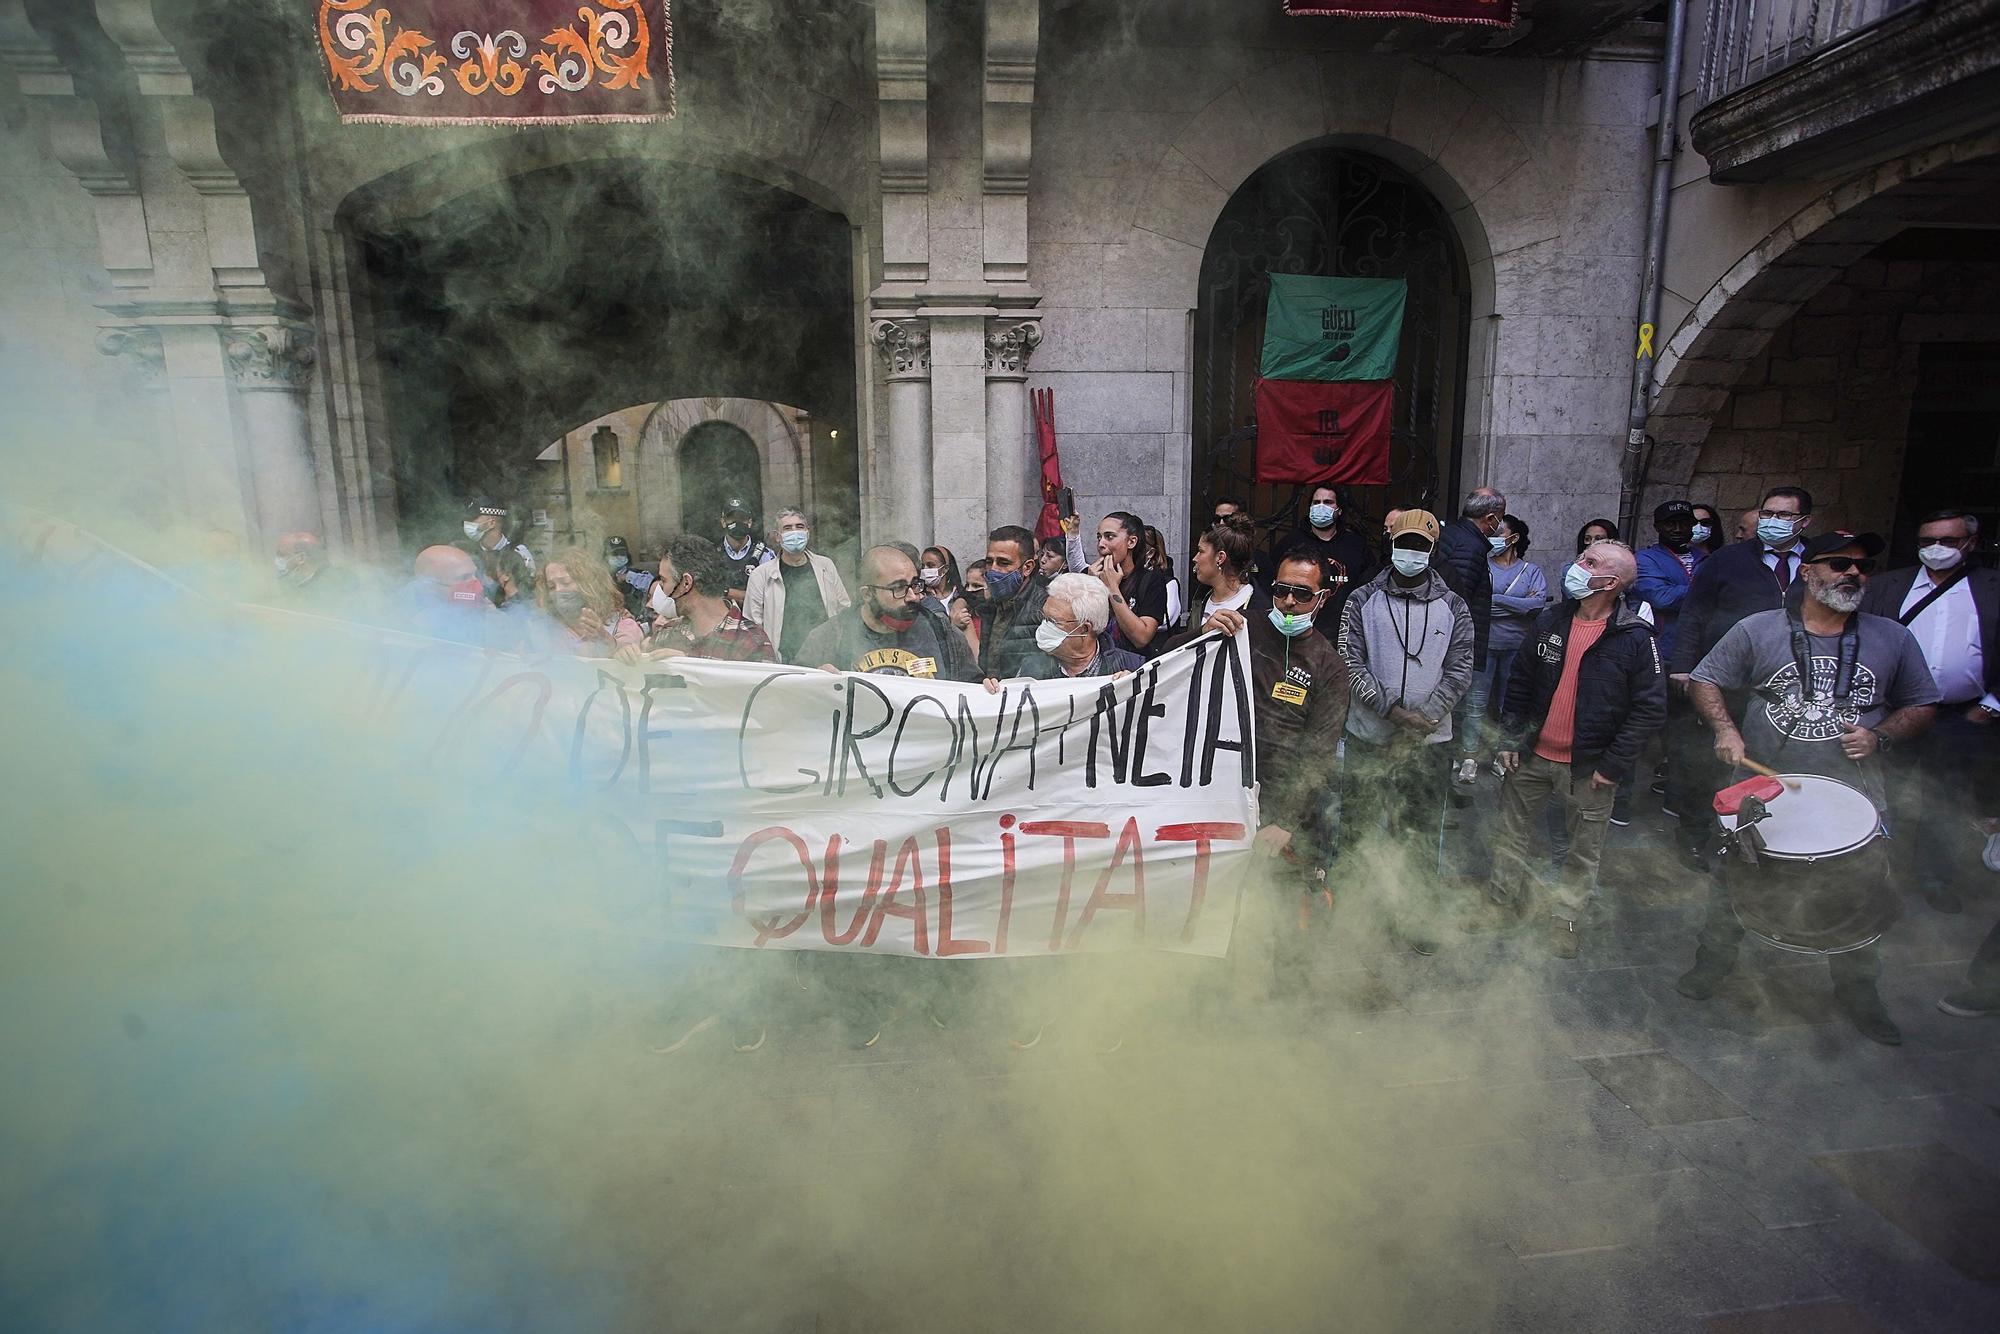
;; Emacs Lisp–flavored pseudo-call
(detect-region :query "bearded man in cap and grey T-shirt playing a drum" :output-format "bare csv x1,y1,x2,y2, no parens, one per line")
1676,532,1938,1046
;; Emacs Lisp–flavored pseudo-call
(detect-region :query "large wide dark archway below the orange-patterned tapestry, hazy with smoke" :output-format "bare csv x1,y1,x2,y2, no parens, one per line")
342,158,860,544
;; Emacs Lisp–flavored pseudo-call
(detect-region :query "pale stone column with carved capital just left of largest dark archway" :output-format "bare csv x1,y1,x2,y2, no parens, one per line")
222,322,322,546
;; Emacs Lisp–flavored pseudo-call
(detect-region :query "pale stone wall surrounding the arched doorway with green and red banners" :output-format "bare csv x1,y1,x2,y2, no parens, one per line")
1028,24,1656,580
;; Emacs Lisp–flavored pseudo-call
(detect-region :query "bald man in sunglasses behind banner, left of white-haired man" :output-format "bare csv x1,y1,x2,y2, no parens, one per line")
798,546,980,680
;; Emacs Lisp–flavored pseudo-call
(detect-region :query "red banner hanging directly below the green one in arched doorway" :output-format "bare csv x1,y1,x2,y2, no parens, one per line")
1256,380,1396,486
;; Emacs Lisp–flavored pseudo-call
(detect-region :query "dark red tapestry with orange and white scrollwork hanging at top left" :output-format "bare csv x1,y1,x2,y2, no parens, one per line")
310,0,674,126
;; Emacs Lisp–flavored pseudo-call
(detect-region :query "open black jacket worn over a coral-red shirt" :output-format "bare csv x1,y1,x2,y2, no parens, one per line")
1500,598,1666,786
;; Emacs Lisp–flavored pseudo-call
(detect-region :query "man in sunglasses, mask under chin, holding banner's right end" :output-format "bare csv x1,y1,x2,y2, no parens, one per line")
1202,546,1348,996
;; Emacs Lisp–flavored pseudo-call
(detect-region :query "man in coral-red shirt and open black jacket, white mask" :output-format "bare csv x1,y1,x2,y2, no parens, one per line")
1466,542,1666,958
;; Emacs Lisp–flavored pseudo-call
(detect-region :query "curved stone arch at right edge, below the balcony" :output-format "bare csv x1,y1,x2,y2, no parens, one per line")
1640,134,2000,514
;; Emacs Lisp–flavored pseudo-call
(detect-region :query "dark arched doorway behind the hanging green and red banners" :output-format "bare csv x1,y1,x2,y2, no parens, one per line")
1190,146,1470,532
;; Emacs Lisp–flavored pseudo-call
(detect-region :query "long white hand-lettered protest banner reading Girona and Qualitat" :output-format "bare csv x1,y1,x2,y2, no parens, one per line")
7,520,1258,960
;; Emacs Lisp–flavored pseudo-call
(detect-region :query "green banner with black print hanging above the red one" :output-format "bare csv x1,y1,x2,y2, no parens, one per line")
1258,274,1410,380
